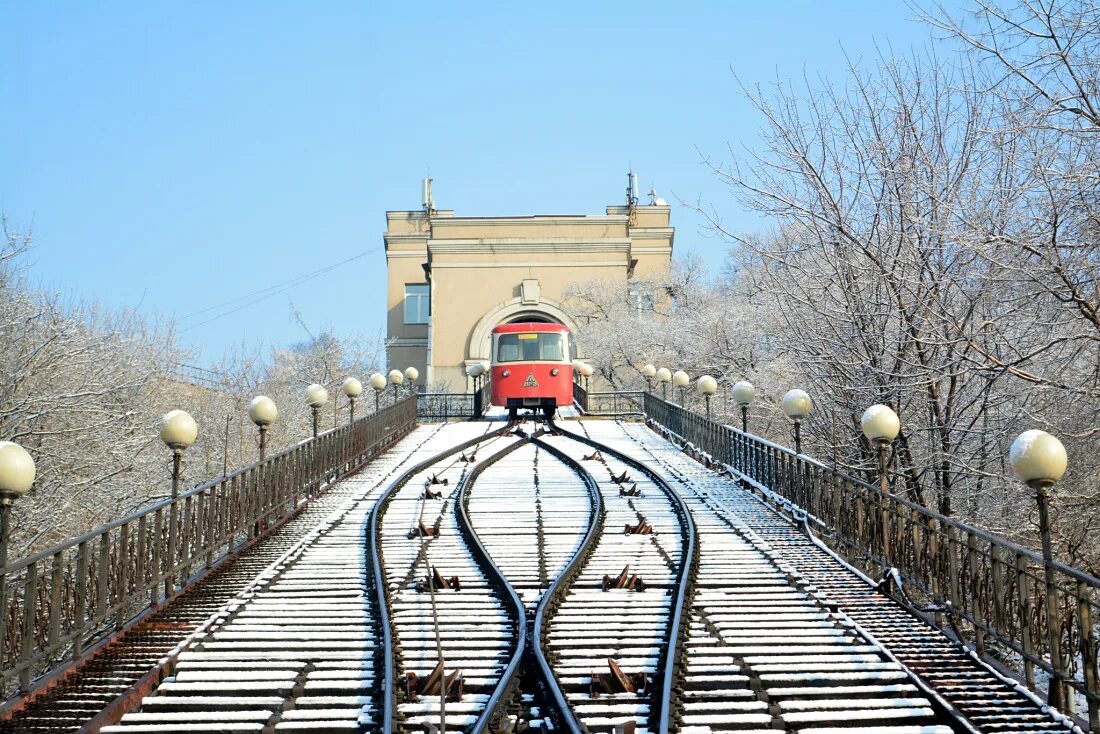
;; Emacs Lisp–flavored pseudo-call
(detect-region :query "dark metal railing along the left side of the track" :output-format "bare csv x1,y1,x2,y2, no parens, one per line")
0,398,417,698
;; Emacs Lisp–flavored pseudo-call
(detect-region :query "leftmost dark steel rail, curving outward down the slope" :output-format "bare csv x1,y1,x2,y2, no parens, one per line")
367,423,512,734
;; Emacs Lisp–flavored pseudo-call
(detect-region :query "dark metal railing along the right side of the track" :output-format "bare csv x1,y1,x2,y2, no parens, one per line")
645,393,1100,732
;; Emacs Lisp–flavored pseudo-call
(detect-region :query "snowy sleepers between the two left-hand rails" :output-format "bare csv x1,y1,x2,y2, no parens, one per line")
378,424,519,731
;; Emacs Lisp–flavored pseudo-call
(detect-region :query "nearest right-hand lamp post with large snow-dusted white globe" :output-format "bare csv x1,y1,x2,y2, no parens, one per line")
1009,430,1069,711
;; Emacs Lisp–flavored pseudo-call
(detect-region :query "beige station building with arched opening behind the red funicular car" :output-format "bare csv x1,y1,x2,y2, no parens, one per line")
384,176,674,392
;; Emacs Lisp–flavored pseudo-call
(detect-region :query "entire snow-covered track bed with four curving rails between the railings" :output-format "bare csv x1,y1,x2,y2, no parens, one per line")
21,413,1042,734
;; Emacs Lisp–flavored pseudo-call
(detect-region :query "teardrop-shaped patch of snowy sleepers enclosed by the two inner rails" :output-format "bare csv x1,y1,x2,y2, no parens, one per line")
468,443,592,611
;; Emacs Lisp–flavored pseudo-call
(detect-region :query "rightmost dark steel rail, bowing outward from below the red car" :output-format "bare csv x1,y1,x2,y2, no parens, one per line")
550,421,699,734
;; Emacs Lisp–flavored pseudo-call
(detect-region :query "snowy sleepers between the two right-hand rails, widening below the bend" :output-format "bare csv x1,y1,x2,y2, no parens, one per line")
543,437,683,732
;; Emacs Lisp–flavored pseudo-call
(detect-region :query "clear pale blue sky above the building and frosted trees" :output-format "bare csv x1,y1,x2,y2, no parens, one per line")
0,0,963,363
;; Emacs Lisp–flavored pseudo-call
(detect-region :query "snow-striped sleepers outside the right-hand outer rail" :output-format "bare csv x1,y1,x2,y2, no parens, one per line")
567,421,952,734
